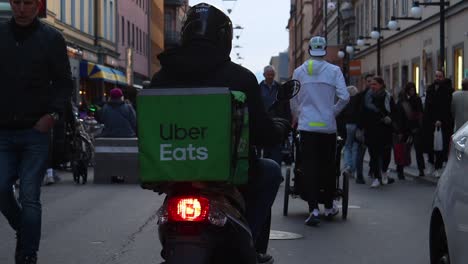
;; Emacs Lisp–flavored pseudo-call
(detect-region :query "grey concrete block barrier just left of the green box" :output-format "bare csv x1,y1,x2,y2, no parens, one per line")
93,138,139,184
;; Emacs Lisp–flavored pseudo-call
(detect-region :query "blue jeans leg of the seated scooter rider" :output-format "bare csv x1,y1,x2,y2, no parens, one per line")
245,159,283,241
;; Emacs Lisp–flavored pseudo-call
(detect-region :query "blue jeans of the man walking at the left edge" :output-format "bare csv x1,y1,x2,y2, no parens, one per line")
0,129,50,256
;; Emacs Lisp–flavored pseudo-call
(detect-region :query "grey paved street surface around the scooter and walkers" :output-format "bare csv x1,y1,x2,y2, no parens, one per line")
0,168,434,264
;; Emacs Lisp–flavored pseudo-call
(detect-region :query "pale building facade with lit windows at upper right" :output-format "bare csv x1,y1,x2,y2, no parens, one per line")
354,0,468,95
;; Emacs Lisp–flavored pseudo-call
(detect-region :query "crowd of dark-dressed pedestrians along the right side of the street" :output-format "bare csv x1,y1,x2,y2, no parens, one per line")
337,70,468,188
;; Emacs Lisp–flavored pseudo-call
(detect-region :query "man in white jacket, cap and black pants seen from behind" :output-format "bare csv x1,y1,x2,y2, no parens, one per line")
291,36,349,226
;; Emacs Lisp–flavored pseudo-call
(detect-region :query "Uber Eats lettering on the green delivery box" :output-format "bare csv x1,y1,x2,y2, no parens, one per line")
159,124,208,161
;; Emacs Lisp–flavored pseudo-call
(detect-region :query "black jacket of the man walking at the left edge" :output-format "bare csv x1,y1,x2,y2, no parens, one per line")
0,18,73,129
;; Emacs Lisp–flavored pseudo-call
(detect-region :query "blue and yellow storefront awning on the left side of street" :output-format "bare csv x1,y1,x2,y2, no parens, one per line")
80,61,127,85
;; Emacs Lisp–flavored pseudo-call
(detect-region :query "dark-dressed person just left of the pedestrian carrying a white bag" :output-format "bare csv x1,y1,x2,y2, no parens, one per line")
395,82,425,179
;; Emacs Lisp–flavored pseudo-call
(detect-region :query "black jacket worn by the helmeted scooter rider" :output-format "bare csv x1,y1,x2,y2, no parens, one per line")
151,43,283,147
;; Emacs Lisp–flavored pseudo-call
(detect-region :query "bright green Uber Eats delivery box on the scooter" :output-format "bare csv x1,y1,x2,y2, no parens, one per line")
137,88,248,187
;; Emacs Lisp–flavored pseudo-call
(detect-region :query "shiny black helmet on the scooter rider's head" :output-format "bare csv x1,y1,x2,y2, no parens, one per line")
181,3,233,53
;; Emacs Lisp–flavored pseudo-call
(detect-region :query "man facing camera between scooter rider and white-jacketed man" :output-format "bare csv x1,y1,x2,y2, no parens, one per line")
258,65,291,166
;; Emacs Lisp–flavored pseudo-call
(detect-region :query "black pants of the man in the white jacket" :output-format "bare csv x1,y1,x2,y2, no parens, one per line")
301,131,336,209
